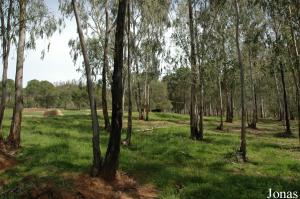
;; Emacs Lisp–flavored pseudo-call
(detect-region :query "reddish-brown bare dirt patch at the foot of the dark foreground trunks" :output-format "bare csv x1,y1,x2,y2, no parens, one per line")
22,174,158,199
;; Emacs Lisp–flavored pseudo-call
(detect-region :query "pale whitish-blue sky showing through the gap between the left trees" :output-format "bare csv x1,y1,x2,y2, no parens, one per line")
0,0,81,86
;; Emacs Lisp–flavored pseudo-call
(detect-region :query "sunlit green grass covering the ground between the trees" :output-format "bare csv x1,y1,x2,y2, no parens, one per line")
0,111,300,199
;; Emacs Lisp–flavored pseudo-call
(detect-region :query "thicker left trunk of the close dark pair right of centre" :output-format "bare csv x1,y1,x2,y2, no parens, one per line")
188,0,202,139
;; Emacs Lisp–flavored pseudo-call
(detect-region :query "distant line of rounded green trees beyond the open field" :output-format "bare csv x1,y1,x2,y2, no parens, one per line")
0,79,172,111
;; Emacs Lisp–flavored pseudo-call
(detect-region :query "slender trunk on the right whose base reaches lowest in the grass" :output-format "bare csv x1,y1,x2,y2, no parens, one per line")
235,0,247,161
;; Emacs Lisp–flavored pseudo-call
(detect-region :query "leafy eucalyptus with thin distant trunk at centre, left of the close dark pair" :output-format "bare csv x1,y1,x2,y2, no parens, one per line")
135,0,171,120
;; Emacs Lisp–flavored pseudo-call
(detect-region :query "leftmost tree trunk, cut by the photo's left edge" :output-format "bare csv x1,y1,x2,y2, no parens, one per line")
0,0,13,140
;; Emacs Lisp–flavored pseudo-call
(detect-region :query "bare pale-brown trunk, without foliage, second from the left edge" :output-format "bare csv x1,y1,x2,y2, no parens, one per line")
7,0,27,149
